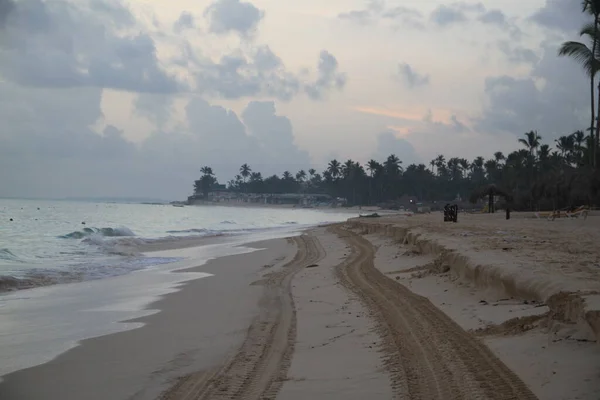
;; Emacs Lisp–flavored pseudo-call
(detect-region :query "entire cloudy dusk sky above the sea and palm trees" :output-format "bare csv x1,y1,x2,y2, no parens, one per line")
0,0,590,200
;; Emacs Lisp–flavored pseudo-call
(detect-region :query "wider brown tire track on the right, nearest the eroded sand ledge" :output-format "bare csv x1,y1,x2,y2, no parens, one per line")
329,225,536,400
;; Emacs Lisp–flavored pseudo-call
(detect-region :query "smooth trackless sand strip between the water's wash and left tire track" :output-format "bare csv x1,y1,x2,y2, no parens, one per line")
0,239,293,400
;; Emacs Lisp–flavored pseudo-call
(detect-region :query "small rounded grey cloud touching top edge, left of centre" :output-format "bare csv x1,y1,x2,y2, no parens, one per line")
204,0,264,36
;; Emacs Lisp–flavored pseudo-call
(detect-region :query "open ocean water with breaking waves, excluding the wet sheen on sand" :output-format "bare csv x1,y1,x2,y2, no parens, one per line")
0,199,348,292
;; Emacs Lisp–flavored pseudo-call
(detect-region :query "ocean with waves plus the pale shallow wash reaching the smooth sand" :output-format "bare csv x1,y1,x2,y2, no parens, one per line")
0,199,356,381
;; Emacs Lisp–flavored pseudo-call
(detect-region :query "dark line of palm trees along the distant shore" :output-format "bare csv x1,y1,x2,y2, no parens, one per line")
195,131,599,210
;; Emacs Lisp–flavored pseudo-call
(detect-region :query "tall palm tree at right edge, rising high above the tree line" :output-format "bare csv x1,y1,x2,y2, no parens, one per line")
558,17,600,165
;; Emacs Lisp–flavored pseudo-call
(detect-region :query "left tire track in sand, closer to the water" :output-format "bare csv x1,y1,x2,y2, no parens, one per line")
161,235,324,400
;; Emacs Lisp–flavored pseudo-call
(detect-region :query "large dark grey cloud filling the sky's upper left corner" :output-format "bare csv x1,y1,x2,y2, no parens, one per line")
0,0,187,93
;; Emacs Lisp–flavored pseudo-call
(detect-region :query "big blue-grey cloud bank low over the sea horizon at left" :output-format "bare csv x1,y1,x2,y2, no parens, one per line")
0,82,310,199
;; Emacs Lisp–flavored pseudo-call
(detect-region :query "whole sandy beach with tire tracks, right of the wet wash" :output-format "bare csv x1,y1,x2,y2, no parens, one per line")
0,213,600,400
